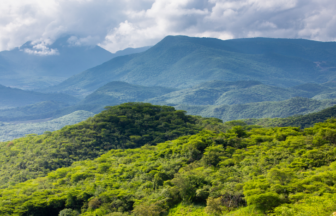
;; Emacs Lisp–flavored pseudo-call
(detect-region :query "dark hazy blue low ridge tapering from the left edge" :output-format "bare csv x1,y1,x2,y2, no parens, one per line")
0,85,79,109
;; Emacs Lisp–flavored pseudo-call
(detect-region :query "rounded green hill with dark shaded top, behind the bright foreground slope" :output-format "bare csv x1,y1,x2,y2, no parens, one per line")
0,103,202,187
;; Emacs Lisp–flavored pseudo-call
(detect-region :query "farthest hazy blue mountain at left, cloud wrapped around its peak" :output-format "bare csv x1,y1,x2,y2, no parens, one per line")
0,37,148,89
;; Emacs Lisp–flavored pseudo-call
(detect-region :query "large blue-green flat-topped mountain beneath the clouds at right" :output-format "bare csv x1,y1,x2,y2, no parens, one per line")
49,36,336,95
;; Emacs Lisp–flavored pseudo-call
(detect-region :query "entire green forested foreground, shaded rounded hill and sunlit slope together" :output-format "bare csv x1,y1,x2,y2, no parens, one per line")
0,103,336,216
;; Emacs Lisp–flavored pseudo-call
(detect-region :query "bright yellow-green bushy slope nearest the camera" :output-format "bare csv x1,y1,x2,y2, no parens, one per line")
0,115,336,216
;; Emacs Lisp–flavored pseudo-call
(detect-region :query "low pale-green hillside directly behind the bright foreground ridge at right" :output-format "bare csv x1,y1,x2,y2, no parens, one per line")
175,98,336,121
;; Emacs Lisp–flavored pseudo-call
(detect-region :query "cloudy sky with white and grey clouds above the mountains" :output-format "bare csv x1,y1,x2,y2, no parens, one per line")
0,0,336,55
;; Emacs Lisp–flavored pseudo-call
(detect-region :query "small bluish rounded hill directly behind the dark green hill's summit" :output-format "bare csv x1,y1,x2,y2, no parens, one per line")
81,81,175,106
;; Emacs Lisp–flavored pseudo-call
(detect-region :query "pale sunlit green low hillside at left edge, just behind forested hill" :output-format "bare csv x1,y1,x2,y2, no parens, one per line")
0,110,94,141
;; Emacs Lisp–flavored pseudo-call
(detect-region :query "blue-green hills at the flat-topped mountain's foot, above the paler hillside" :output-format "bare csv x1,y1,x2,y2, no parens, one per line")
147,81,316,105
